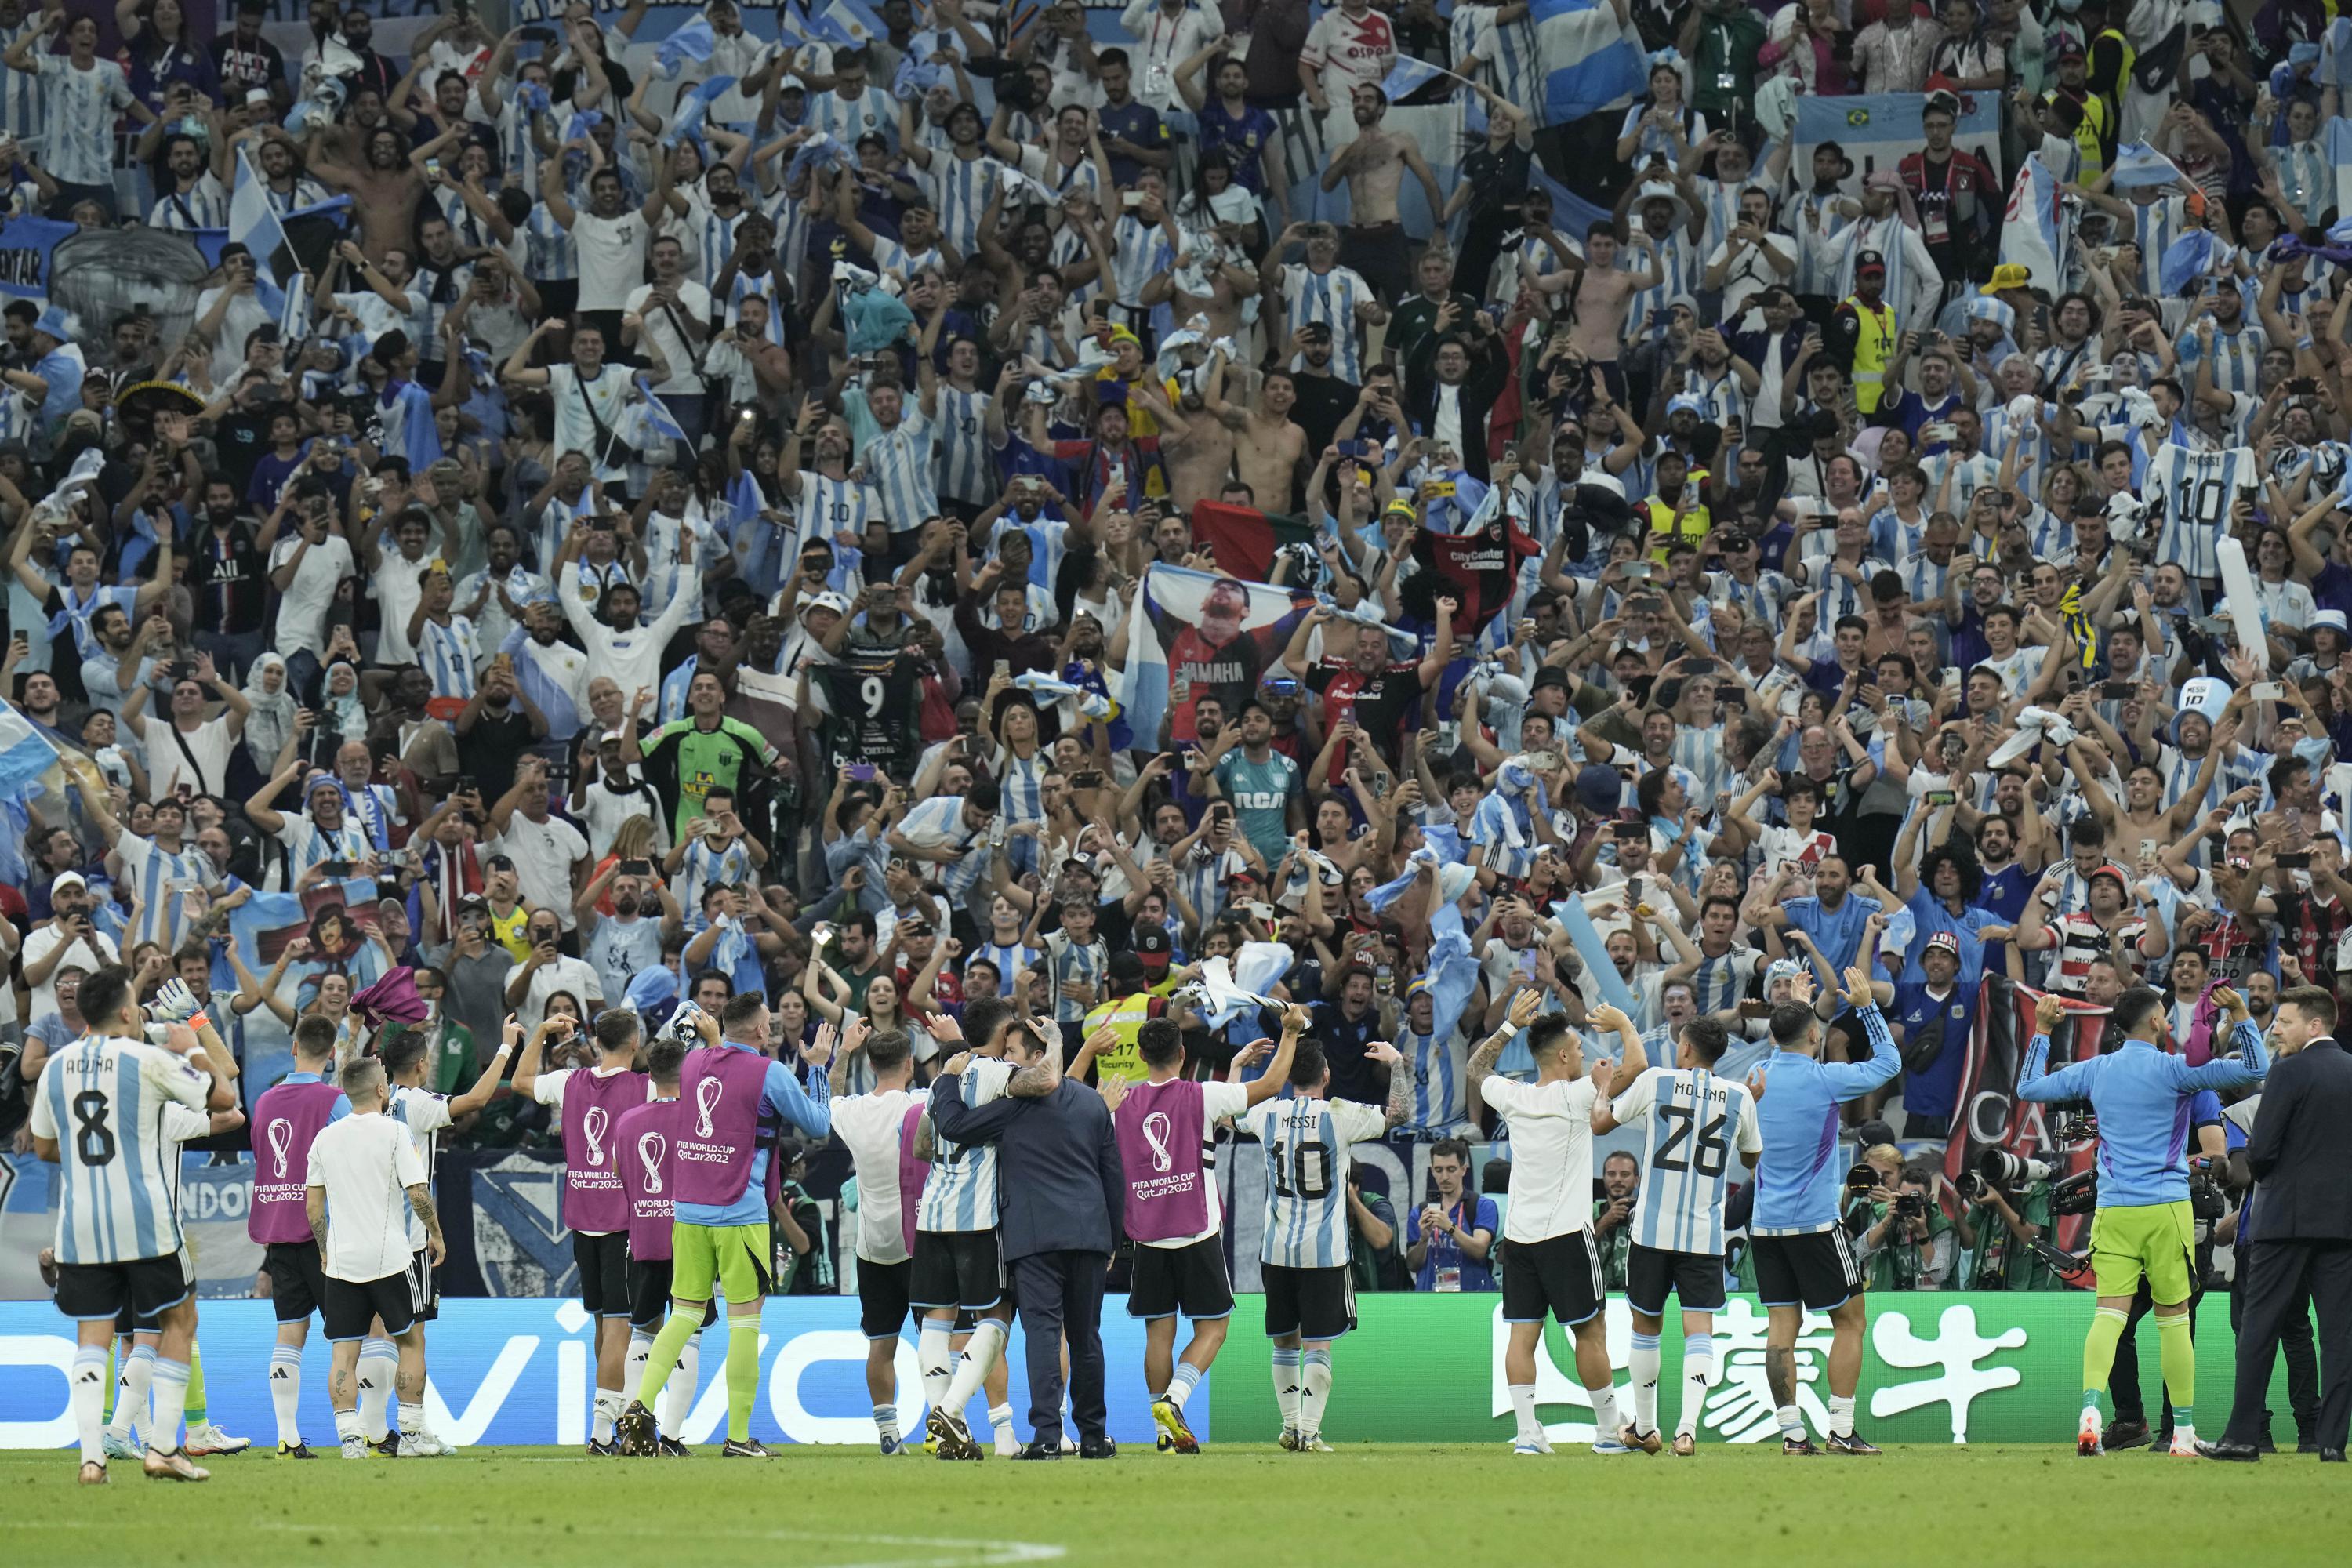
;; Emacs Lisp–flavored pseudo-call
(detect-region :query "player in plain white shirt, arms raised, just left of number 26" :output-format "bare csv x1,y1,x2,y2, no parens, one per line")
1470,987,1649,1455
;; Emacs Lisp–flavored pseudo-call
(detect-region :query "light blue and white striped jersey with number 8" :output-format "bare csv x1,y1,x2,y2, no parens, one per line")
31,1034,212,1262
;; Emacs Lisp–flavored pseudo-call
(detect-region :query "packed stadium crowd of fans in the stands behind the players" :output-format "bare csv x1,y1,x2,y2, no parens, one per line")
0,0,2352,1476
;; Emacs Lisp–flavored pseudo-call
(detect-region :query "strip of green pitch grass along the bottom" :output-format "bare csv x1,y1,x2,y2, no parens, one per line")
0,1443,2352,1568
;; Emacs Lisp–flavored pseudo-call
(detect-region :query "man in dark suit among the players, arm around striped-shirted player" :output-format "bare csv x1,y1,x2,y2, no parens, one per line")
931,1020,1127,1460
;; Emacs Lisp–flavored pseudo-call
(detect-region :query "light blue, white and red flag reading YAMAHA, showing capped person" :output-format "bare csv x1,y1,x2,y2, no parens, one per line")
1112,567,1315,746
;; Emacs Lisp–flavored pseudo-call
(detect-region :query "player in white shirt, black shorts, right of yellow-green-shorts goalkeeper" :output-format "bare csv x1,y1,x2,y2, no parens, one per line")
833,1018,927,1457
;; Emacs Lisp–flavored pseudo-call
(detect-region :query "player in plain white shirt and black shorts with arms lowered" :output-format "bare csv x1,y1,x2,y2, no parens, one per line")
303,1055,449,1460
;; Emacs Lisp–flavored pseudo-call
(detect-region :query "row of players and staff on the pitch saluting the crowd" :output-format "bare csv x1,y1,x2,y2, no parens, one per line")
31,949,2265,1483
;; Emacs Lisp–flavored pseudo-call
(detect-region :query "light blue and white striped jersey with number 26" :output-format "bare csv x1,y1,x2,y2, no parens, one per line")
1613,1067,1764,1255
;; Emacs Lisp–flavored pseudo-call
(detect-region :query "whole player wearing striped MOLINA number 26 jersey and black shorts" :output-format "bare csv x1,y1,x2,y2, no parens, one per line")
1592,1018,1764,1460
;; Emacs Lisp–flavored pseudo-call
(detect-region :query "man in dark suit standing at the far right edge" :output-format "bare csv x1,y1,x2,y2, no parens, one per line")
2197,985,2352,1465
